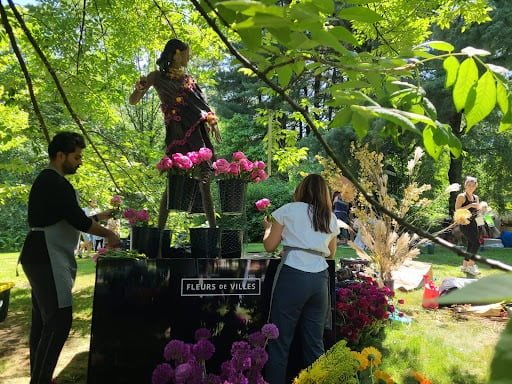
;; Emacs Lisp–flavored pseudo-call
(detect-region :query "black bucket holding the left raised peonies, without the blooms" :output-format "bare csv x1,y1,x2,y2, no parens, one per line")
167,174,199,212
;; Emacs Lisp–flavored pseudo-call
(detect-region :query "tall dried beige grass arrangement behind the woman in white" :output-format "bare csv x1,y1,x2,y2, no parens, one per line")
321,145,460,283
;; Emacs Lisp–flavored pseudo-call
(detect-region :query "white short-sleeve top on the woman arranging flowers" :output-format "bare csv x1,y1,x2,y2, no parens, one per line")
272,202,340,273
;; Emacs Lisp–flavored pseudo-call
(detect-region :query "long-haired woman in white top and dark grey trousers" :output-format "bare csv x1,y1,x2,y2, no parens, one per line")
263,174,340,384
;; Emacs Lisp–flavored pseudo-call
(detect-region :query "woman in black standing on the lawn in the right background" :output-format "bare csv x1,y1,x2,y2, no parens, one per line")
455,176,480,276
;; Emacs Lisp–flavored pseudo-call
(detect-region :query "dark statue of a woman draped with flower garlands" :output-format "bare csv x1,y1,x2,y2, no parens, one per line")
129,39,220,229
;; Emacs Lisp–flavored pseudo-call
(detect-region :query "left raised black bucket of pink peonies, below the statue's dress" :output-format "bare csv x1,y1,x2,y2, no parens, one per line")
156,148,213,212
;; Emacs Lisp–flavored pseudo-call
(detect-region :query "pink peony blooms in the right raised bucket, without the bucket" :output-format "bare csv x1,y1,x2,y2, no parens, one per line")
212,152,267,183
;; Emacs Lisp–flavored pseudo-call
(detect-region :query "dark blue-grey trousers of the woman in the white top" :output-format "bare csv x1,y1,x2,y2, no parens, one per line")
265,265,329,384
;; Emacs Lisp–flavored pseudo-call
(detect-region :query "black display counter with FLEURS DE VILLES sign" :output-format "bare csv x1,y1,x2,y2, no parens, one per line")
87,258,335,384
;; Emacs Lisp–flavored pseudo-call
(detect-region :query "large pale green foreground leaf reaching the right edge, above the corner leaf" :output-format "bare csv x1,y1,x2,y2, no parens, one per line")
436,273,512,304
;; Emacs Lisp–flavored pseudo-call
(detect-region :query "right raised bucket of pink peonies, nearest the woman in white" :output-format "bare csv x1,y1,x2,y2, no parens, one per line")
212,152,267,213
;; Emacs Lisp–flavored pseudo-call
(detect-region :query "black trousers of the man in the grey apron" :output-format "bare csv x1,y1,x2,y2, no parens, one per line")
23,264,73,384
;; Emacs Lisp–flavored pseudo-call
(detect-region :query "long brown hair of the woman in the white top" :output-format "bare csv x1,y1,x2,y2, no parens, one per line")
293,173,332,233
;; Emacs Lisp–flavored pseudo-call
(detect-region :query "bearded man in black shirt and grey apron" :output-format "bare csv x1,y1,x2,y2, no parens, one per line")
20,132,119,384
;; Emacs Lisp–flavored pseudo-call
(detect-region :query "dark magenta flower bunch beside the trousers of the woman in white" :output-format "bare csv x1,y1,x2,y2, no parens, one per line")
336,276,395,345
